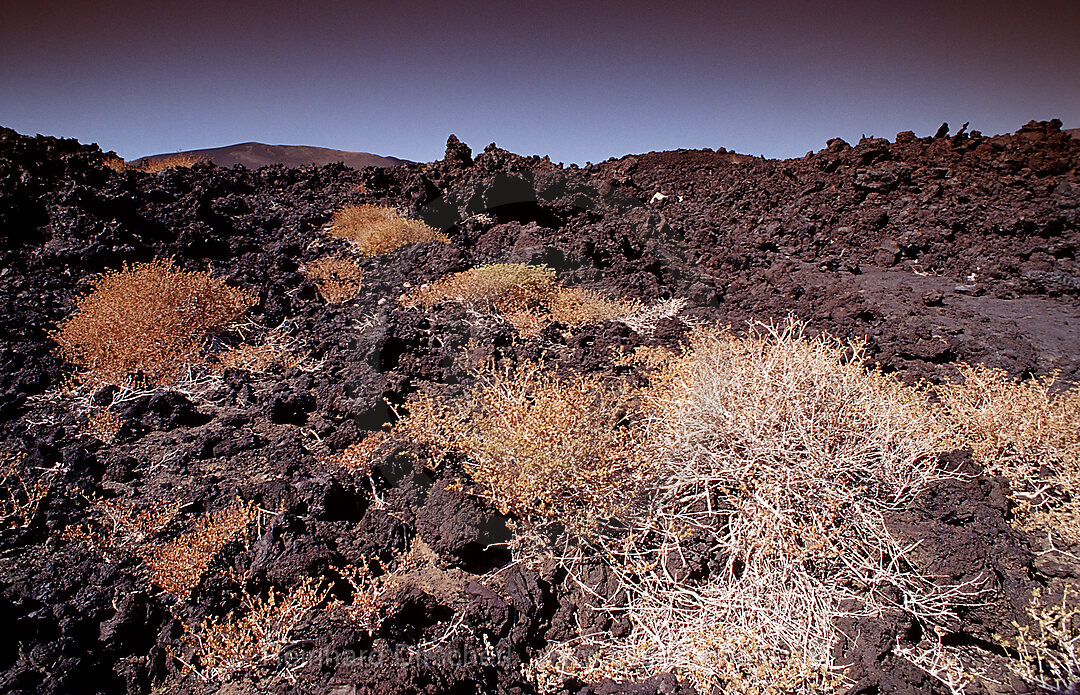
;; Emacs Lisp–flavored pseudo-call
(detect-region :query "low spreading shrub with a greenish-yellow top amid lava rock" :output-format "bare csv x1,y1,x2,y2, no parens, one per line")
401,263,639,336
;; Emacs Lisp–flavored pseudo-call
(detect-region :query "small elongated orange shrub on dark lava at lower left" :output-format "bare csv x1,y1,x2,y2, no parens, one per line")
140,504,257,599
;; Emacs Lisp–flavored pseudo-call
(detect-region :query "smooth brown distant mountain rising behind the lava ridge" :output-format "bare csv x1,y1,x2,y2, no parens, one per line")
131,142,407,169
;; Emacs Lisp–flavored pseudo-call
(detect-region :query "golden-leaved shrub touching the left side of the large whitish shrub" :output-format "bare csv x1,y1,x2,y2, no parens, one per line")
395,363,651,533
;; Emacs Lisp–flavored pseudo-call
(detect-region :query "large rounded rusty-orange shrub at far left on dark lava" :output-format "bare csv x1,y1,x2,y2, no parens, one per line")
52,259,256,384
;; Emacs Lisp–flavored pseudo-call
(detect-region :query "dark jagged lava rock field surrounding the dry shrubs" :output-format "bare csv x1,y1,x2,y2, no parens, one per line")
0,121,1080,695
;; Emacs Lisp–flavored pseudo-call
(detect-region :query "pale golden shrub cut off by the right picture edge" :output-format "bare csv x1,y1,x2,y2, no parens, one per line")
937,366,1080,544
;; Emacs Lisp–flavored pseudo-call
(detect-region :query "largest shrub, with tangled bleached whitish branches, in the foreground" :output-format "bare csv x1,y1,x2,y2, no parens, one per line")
548,324,962,693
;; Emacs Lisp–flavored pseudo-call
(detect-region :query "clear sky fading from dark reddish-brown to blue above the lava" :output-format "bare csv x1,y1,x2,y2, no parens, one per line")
0,0,1080,164
